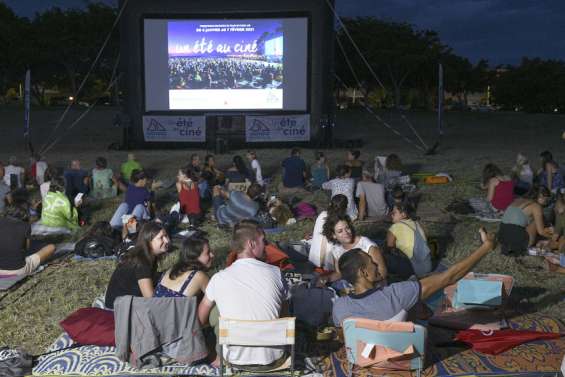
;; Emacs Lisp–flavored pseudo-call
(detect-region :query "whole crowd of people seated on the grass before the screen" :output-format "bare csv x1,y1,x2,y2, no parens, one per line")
0,149,565,371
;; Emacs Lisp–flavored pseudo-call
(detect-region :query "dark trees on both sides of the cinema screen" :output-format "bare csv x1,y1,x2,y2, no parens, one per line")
0,2,565,112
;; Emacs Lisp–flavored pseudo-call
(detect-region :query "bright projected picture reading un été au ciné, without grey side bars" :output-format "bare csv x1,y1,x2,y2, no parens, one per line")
167,19,285,109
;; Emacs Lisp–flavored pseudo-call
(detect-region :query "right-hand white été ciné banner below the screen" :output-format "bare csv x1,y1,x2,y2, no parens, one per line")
245,115,310,143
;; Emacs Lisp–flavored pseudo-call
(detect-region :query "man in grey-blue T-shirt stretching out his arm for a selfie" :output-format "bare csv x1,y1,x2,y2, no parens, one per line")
333,228,495,326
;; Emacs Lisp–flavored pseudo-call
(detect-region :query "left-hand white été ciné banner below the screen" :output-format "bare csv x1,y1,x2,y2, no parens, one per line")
143,115,206,143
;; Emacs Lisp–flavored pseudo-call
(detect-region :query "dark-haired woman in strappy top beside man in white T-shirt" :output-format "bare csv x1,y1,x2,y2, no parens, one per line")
155,237,214,297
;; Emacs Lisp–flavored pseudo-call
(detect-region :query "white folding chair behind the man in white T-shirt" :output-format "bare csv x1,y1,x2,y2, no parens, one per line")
218,317,296,377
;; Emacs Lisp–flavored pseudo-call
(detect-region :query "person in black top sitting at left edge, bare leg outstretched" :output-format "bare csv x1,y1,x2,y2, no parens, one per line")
0,204,55,276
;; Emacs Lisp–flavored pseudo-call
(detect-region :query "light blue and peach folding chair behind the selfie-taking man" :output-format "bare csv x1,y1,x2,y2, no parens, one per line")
343,318,427,374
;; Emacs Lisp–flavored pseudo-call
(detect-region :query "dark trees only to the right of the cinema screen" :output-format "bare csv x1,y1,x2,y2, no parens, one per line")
335,17,565,112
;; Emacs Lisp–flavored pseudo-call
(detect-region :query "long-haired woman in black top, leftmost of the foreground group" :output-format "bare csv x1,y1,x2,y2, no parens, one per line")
105,222,170,309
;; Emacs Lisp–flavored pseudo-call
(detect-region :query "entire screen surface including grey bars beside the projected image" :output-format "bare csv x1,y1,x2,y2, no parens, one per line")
144,18,308,111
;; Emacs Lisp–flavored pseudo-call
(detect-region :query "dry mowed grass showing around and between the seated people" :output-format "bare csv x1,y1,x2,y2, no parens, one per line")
0,110,565,353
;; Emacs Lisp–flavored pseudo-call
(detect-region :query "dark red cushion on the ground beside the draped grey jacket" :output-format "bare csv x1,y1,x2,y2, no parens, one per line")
59,308,116,346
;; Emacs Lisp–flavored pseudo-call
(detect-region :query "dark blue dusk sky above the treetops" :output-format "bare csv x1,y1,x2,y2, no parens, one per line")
4,0,565,66
